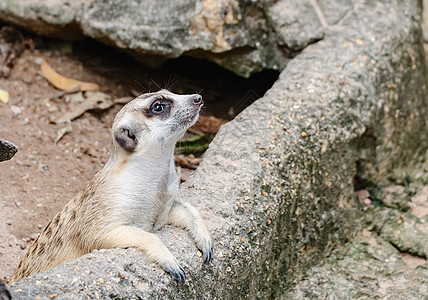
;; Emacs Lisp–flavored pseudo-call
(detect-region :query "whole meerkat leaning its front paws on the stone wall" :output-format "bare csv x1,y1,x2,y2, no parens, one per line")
11,90,213,282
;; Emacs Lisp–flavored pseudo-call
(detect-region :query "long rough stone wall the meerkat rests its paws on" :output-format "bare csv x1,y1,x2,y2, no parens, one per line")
5,0,428,299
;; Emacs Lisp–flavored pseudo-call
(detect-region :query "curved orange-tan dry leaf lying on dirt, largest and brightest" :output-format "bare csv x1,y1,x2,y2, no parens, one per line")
40,61,100,91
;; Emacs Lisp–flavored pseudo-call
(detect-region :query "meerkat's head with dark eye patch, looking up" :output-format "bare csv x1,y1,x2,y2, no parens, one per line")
112,90,204,153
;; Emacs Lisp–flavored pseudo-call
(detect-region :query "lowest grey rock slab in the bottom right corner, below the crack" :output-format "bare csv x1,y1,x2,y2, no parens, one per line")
281,232,428,300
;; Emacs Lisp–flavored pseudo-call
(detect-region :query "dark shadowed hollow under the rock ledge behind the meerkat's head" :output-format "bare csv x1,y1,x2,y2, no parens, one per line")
73,40,279,120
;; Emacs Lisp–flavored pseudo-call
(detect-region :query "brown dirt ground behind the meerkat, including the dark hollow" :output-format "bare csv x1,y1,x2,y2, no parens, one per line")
0,25,278,281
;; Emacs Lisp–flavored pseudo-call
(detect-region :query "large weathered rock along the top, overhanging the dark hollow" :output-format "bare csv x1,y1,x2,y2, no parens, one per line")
0,0,352,76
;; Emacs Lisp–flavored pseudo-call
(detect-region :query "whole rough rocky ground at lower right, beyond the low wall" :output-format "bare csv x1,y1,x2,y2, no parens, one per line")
283,184,428,300
